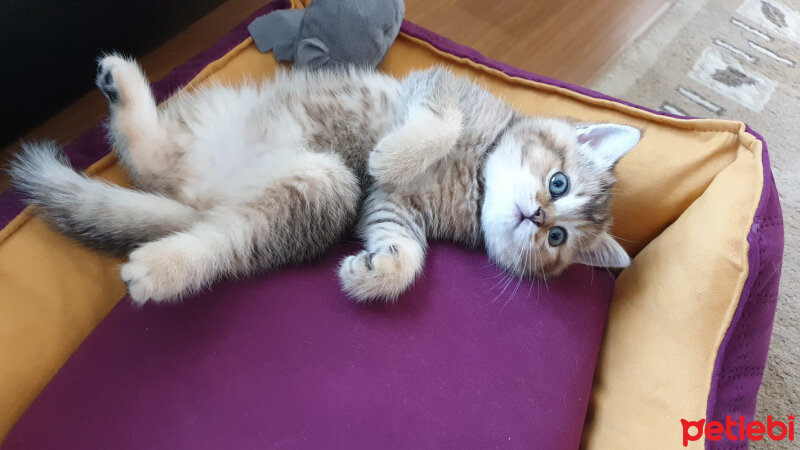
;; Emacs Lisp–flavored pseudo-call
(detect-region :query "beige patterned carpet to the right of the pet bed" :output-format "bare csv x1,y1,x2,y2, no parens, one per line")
591,0,800,449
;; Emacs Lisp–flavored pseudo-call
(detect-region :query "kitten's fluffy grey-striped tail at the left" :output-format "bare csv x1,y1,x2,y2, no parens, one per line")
9,142,199,255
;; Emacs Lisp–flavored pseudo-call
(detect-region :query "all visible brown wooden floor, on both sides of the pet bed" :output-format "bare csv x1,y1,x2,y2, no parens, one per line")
0,0,669,191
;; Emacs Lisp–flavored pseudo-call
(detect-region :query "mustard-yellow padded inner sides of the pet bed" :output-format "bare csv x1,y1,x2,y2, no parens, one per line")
0,2,776,449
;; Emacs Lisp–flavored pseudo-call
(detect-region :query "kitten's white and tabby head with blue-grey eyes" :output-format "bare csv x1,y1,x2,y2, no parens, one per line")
481,118,641,278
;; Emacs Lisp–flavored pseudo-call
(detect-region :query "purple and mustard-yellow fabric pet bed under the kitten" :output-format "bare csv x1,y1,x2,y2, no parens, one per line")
0,0,783,449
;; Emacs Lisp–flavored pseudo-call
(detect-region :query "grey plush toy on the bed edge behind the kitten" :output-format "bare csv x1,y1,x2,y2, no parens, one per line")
247,0,405,68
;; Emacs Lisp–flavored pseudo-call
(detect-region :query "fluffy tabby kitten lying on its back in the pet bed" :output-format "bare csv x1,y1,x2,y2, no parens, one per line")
11,55,640,303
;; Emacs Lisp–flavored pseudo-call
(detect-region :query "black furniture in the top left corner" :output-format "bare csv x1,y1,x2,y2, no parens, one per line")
0,0,223,146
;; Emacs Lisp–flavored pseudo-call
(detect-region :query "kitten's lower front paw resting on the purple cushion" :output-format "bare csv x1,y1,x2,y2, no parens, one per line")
339,245,421,302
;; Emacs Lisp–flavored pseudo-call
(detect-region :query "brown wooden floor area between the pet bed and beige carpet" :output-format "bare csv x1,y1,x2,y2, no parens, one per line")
406,0,669,85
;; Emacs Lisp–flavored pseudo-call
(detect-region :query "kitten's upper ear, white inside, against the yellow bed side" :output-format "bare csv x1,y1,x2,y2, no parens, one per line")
576,123,642,168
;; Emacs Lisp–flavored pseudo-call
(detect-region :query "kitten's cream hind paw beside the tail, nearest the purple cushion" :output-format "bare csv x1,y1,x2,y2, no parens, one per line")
120,237,200,305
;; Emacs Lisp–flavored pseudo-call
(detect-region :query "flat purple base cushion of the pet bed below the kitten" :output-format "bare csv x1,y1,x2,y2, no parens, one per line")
4,244,613,450
